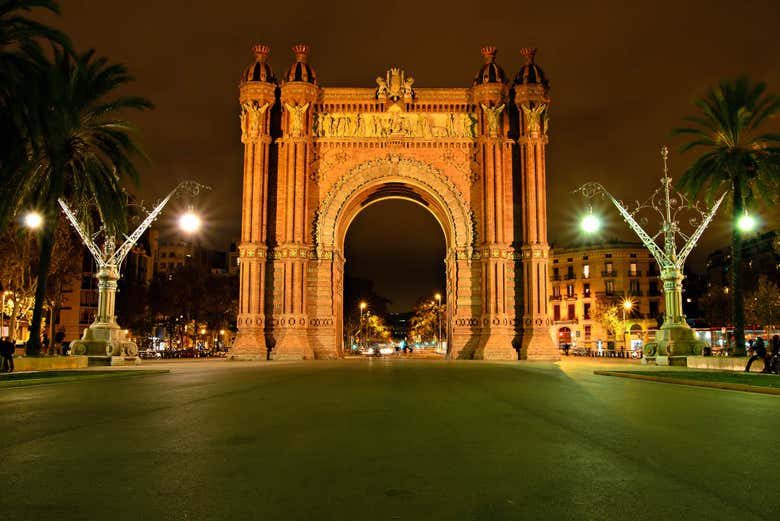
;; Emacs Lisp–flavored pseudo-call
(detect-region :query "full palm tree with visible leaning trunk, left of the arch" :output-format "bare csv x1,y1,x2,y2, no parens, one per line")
0,49,152,355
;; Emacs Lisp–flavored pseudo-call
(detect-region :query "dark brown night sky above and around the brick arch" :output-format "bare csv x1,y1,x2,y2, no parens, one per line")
38,0,780,306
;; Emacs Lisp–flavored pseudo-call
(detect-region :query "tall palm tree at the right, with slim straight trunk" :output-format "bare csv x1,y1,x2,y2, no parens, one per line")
674,77,780,354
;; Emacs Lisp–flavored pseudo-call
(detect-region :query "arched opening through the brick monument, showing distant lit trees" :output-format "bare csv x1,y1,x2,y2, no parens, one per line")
343,197,448,355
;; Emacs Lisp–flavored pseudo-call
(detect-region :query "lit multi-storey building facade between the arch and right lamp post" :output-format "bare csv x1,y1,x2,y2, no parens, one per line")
549,242,664,350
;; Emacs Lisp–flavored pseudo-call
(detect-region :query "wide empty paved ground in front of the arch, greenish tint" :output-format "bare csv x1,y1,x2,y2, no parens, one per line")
0,360,780,521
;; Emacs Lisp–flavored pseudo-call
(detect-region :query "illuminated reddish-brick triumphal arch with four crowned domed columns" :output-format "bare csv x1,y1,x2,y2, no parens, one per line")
233,45,557,360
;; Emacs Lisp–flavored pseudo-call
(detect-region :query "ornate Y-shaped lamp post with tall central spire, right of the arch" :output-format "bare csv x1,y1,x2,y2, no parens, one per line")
575,147,726,365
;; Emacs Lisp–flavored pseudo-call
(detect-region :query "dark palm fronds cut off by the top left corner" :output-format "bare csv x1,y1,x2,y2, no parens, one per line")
0,0,70,189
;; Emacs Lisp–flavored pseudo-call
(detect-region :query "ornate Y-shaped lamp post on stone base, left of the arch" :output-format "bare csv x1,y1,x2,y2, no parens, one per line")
59,181,208,360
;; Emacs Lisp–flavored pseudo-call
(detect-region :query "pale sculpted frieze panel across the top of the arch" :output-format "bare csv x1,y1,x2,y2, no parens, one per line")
314,112,477,139
